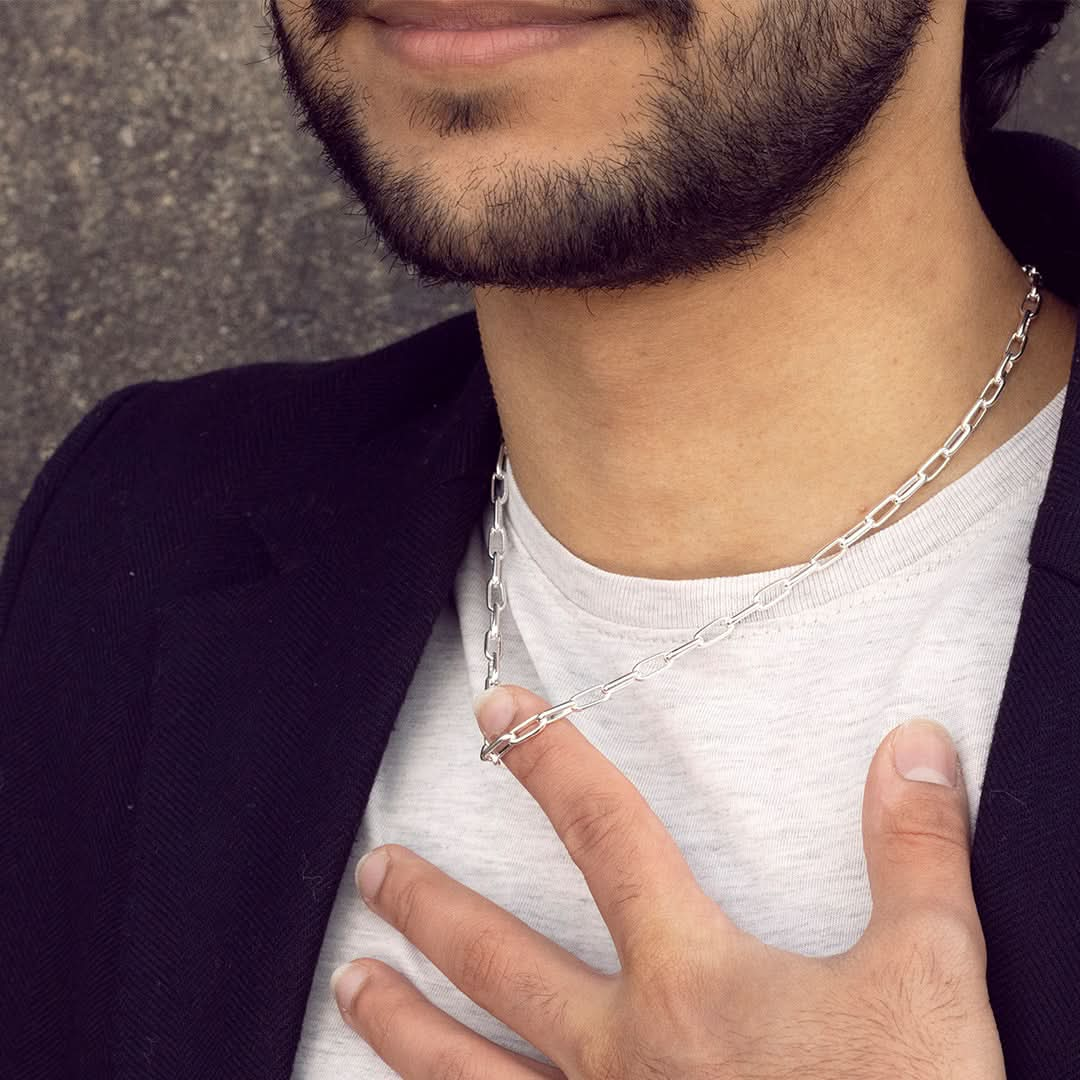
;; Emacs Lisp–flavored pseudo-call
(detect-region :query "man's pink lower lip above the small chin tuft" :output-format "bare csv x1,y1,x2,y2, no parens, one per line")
373,15,623,68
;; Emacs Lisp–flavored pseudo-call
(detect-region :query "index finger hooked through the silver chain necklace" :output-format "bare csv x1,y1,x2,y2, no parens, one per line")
474,685,734,968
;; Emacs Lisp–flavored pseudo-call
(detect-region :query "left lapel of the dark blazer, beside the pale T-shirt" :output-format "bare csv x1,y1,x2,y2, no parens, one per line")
114,336,501,1080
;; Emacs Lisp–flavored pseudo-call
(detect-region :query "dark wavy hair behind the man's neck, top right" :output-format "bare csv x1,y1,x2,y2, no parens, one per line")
960,0,1072,151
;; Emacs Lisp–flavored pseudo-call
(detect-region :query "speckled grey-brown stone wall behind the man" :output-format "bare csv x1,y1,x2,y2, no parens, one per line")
0,0,1080,551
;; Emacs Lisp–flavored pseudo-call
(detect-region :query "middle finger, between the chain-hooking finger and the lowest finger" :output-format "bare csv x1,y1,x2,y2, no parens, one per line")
356,843,610,1061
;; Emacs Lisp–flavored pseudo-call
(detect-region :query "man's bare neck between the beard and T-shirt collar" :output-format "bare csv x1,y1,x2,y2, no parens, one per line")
475,128,1077,579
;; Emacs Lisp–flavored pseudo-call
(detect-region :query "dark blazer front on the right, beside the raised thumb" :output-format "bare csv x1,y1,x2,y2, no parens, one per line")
972,315,1080,1078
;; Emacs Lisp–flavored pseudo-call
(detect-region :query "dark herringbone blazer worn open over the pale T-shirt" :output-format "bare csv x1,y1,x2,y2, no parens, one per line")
0,132,1080,1080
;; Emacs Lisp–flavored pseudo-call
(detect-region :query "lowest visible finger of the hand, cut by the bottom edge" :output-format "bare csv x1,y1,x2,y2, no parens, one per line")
330,958,566,1080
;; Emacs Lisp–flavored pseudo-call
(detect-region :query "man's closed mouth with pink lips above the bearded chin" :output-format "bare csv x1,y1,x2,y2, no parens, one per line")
370,12,627,70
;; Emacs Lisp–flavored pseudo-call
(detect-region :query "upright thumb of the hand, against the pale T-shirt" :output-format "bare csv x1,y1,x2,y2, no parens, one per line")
863,719,983,959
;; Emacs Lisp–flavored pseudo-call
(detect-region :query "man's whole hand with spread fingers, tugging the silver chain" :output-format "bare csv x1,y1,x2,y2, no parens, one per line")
333,687,1005,1080
